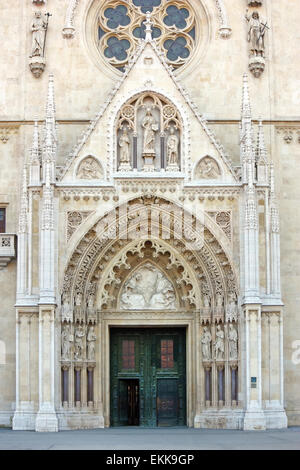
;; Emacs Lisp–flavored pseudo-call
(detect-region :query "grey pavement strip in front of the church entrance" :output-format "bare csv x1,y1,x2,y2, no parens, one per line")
0,427,300,450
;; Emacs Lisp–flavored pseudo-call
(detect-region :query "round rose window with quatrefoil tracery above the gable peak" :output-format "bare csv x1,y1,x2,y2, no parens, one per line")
98,0,196,72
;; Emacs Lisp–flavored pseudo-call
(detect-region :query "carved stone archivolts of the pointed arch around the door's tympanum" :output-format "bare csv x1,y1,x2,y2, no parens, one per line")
62,198,238,321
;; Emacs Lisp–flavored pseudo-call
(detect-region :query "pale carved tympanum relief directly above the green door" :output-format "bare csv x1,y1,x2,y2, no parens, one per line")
121,263,175,310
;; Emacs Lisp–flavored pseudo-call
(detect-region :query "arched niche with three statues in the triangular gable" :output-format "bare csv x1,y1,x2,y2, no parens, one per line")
117,93,182,172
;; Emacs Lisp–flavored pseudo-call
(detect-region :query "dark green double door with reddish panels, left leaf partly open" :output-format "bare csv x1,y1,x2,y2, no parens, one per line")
110,328,186,427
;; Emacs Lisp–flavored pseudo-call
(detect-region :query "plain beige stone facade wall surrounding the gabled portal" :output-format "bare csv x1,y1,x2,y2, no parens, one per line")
0,0,300,425
